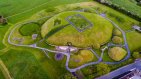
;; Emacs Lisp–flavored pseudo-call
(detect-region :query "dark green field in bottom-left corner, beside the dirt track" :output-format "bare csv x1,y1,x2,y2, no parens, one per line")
0,50,48,79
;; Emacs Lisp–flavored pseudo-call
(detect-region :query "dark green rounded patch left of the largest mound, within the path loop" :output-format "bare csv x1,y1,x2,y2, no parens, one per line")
19,23,40,36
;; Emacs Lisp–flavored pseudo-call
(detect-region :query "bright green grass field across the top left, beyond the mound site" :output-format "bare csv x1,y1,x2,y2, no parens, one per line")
0,0,89,23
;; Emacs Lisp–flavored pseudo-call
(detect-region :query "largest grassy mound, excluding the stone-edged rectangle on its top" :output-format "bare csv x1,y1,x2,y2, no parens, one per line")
41,11,113,47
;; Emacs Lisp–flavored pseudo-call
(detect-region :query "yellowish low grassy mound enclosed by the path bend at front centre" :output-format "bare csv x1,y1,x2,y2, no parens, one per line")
69,50,96,68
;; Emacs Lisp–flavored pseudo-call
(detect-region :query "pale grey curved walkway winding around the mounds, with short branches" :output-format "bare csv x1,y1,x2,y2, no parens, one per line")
8,10,130,72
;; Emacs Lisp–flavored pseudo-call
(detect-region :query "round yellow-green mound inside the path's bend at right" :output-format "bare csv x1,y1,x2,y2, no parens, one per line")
108,47,127,61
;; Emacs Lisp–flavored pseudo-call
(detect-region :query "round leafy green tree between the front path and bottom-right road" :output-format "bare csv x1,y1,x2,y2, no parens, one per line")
96,63,111,76
